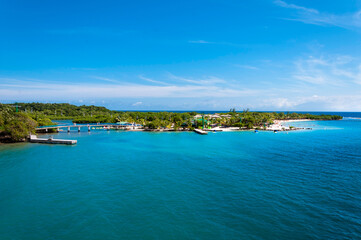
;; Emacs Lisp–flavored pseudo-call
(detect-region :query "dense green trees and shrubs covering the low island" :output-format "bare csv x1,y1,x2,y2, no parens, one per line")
0,103,342,141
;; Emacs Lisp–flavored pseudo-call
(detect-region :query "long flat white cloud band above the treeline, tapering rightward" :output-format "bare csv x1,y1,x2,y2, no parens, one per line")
0,76,260,101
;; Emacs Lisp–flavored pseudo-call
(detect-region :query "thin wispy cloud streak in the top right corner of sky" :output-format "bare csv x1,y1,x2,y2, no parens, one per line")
274,0,361,29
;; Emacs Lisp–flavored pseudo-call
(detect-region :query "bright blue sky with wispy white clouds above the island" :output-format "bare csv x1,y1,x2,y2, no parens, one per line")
0,0,361,111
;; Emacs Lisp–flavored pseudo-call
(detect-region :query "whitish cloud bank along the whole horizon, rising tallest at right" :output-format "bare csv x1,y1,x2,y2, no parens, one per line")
4,62,361,111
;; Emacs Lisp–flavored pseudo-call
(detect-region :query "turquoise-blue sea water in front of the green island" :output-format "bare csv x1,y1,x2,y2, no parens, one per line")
0,120,361,240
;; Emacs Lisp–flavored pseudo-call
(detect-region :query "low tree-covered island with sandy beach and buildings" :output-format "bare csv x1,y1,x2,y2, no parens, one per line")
0,103,342,143
